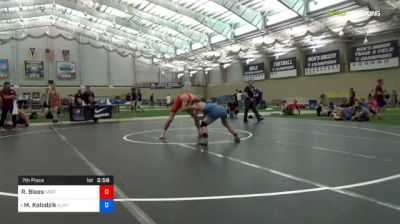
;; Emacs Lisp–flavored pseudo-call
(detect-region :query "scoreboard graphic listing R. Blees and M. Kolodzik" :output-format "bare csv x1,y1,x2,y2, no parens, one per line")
18,176,114,213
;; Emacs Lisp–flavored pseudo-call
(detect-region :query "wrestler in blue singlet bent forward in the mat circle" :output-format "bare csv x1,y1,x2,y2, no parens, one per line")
188,99,240,146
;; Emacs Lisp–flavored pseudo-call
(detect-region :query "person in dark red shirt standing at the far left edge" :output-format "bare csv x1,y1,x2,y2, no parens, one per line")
0,81,17,132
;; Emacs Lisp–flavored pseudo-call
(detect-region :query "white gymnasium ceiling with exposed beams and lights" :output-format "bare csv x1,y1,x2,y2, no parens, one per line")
0,0,400,71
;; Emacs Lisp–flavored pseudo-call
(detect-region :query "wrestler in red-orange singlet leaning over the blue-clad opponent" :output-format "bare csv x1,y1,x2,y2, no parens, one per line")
160,92,200,139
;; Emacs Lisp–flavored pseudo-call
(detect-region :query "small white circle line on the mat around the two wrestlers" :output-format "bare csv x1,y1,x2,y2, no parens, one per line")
123,128,253,145
